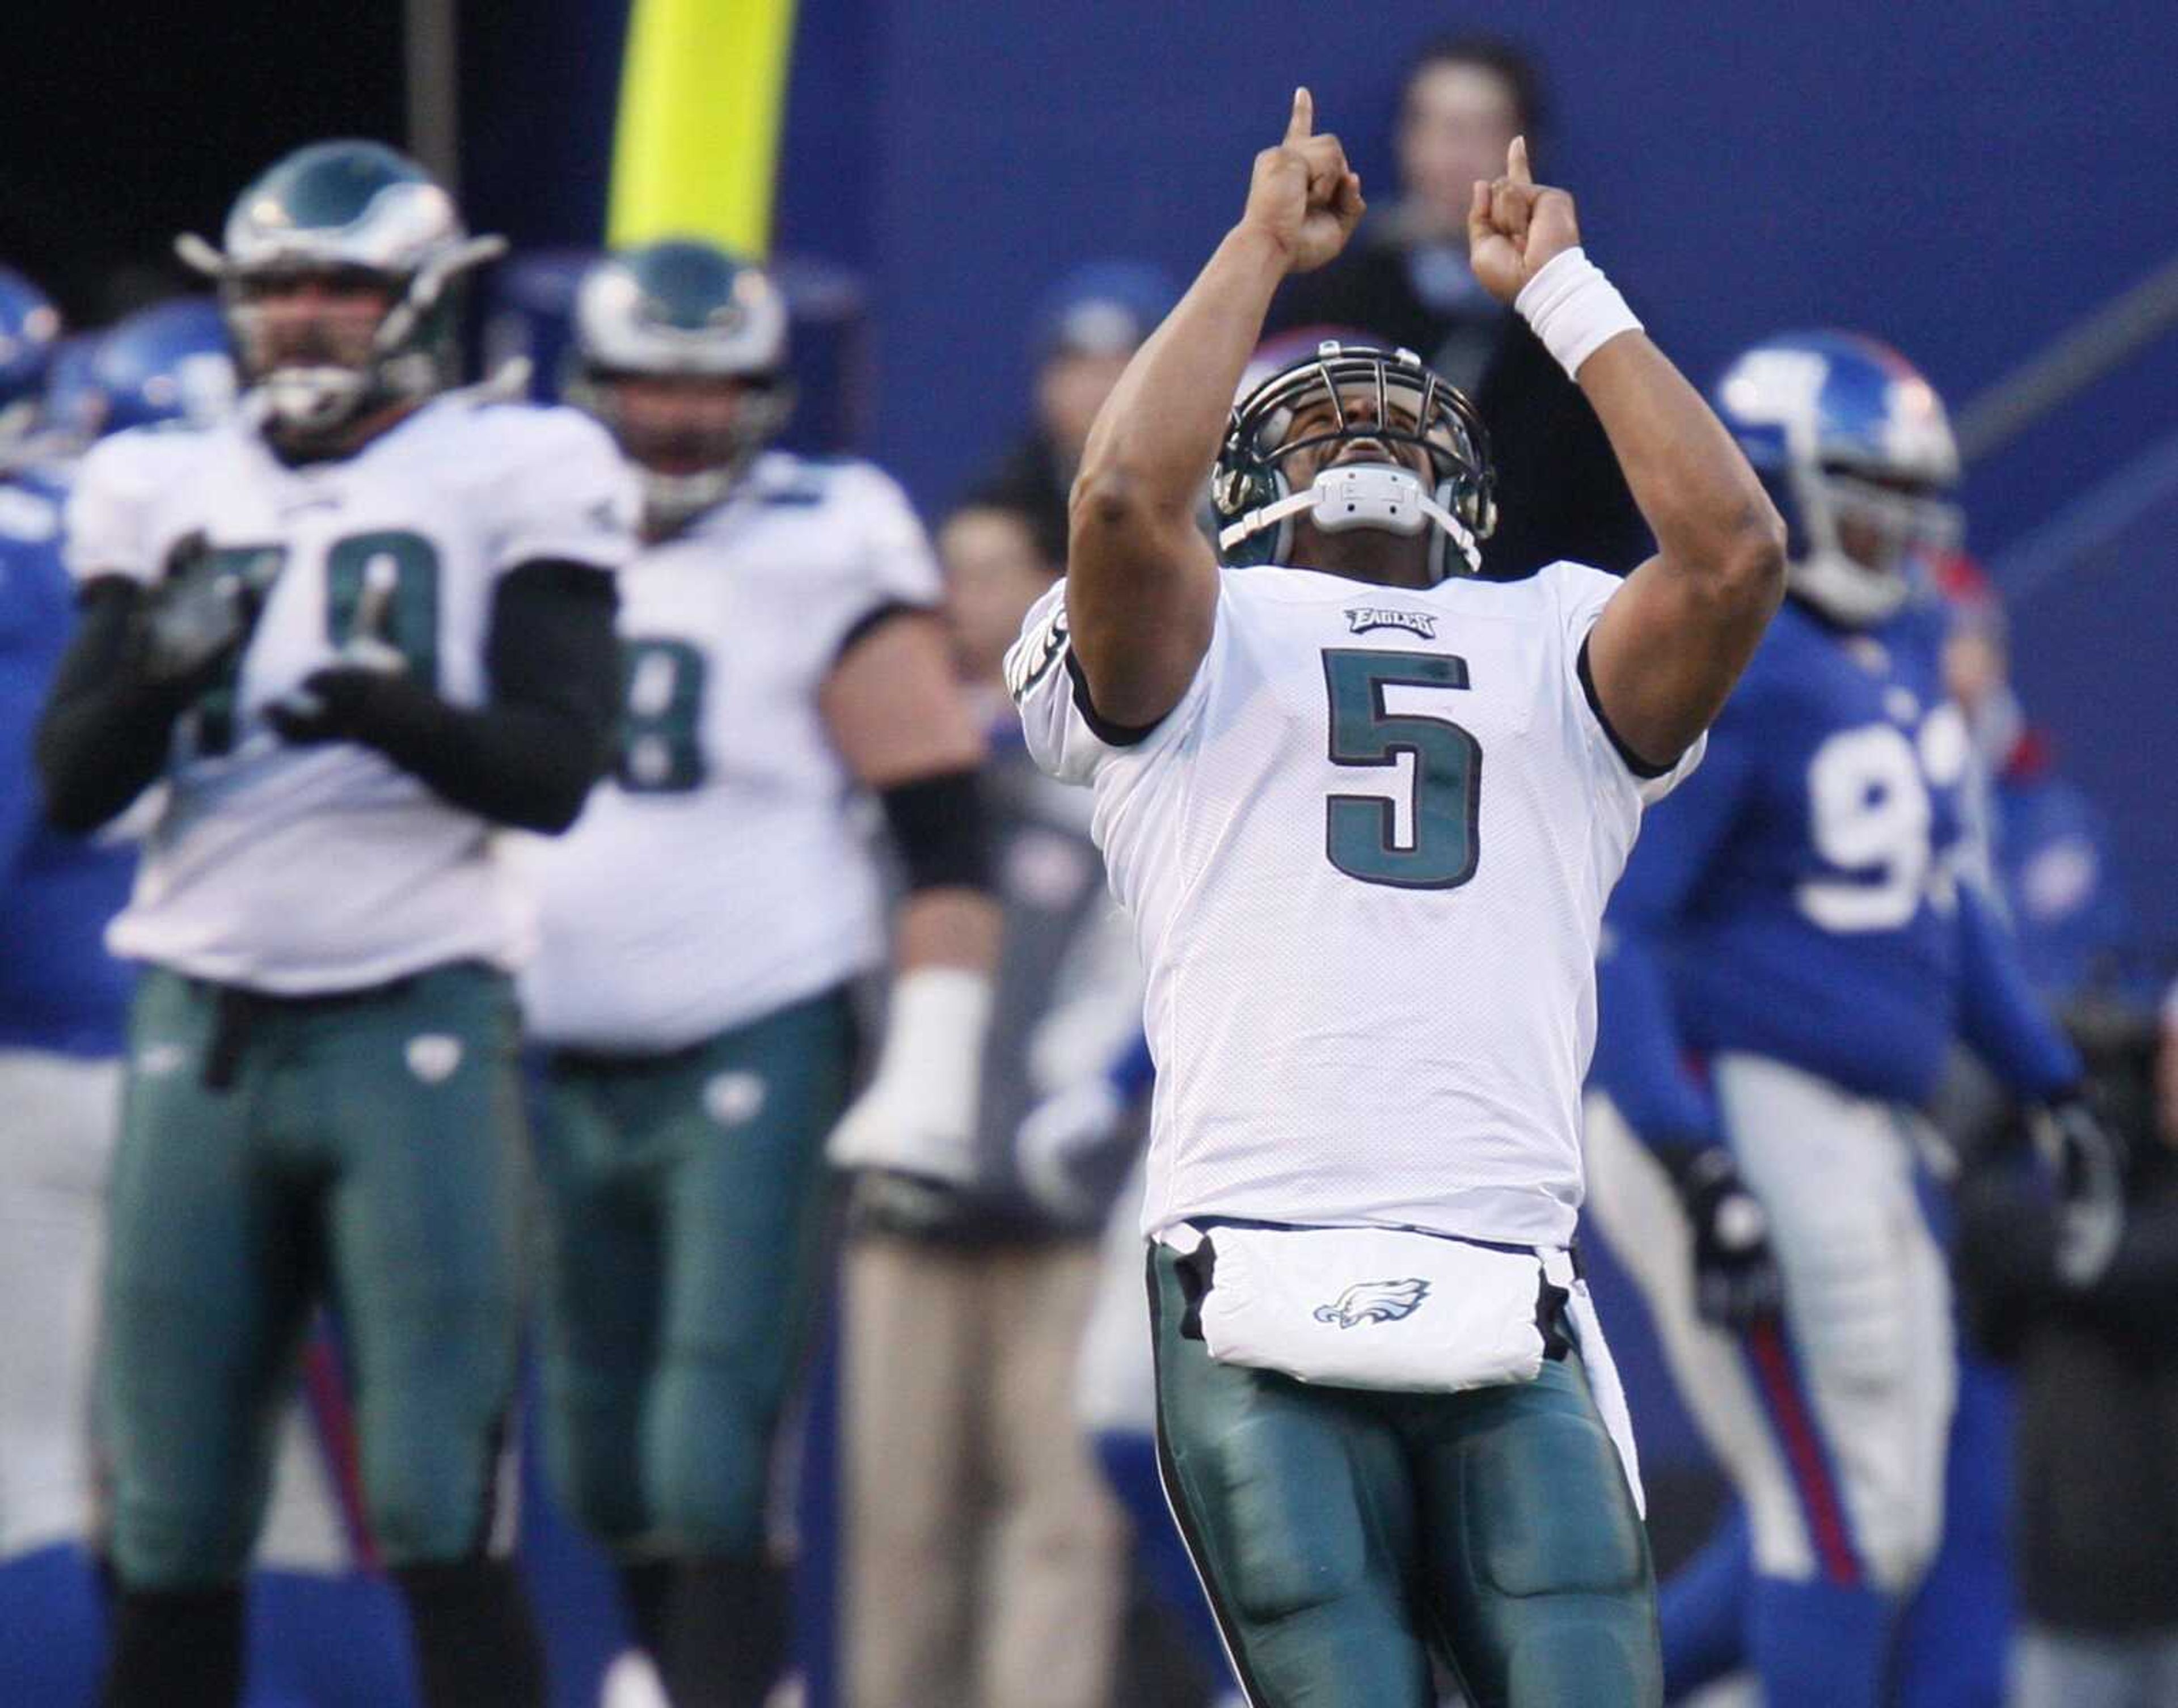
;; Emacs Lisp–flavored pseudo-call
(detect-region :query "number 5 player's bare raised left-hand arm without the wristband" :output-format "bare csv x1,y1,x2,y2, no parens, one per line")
1067,90,1361,728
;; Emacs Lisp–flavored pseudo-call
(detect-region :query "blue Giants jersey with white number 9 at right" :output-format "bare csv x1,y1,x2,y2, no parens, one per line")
1592,601,2078,1137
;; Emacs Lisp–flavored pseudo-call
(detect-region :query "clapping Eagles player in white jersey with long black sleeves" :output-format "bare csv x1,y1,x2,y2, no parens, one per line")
37,142,634,1708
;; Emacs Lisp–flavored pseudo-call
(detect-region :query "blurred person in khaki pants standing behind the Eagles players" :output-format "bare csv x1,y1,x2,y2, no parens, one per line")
847,503,1141,1708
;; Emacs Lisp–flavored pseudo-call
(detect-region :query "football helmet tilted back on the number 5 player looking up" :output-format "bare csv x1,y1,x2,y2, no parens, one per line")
1211,340,1496,582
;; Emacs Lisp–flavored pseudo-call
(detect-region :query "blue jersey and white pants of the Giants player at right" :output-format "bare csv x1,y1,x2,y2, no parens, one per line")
1588,599,2080,1703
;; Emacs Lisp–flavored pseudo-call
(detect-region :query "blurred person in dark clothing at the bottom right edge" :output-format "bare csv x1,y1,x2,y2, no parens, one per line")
1958,989,2178,1708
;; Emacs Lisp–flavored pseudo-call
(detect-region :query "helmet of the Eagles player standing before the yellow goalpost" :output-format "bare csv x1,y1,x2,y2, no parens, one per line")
566,238,793,531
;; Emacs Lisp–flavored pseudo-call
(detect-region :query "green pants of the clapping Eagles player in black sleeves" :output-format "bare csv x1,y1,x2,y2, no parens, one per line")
100,963,525,1591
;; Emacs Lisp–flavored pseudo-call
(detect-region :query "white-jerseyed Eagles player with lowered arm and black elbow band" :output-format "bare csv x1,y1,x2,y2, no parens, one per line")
523,242,998,1708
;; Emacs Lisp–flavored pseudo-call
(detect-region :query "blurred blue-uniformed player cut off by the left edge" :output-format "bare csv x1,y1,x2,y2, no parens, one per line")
0,257,133,1701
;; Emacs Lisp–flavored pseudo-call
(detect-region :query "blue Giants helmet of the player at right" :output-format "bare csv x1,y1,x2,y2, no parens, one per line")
1716,331,1960,627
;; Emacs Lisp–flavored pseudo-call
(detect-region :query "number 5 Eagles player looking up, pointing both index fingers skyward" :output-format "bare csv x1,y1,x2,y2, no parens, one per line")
1011,90,1784,1708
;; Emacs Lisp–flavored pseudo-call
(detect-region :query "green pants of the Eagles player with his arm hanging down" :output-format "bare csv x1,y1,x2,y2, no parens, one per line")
538,991,854,1553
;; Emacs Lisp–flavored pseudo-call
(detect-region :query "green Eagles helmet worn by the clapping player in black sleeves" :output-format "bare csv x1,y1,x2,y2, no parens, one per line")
174,142,508,442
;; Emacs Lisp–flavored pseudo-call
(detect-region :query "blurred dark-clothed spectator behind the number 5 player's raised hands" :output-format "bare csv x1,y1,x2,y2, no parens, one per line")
1265,35,1649,577
